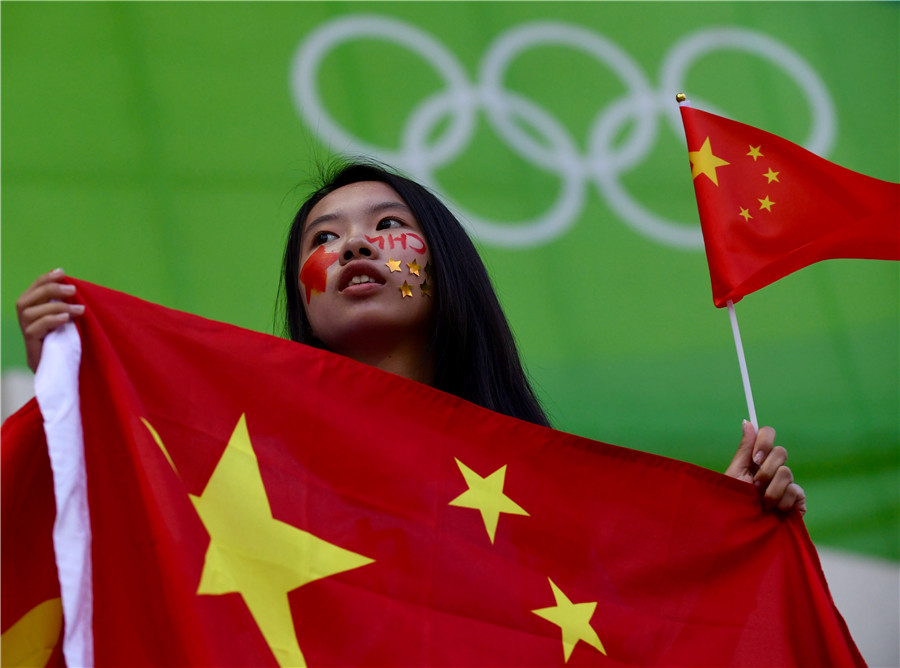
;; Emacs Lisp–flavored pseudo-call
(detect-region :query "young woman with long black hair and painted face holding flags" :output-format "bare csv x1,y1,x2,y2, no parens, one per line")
16,163,806,512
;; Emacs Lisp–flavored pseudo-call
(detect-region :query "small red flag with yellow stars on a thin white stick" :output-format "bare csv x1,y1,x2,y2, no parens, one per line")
681,105,900,308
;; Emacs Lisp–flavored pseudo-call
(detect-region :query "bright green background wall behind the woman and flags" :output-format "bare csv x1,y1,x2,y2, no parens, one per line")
0,2,900,560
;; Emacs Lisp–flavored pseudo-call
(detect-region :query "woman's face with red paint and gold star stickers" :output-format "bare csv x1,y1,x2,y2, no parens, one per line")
298,181,434,357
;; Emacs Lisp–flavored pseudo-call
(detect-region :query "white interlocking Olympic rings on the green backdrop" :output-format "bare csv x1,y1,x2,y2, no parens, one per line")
291,15,835,249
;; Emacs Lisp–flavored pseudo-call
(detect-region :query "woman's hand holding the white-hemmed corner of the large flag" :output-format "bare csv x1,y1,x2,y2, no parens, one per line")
16,269,84,371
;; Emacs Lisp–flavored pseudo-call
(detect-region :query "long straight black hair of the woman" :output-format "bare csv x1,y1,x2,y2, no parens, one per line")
279,162,549,426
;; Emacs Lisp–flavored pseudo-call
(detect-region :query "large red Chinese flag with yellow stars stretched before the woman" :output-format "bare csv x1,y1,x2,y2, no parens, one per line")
3,281,863,666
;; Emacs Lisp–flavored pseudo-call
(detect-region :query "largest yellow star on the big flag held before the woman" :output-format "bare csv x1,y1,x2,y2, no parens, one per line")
144,415,374,666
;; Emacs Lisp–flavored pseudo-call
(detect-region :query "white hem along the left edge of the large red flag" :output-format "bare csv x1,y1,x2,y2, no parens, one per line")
34,322,94,666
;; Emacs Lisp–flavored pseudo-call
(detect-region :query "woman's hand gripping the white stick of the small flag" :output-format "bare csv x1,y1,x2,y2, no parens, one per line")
725,420,806,515
